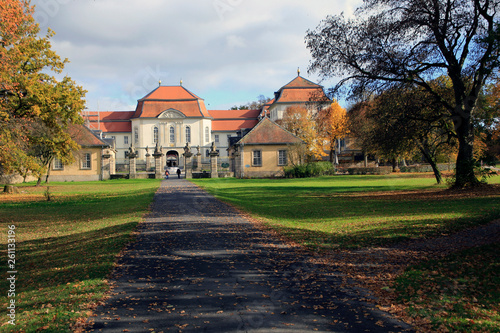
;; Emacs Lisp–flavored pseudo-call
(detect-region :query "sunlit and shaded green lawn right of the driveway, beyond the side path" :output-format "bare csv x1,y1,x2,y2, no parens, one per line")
195,174,500,249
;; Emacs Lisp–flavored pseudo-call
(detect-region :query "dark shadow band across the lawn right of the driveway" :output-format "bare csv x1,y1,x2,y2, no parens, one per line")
208,186,500,222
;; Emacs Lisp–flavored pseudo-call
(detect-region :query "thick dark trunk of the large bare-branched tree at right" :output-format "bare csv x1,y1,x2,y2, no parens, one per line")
453,112,480,188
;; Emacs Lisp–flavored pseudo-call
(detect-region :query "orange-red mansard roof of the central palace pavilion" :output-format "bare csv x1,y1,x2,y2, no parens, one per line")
132,86,210,118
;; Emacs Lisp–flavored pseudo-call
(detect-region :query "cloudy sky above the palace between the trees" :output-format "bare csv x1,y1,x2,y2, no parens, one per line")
32,0,362,111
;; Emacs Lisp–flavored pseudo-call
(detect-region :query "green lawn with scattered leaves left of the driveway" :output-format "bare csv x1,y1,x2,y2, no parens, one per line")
0,180,160,332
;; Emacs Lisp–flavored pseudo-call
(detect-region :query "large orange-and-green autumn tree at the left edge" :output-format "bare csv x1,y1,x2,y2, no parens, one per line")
0,0,85,182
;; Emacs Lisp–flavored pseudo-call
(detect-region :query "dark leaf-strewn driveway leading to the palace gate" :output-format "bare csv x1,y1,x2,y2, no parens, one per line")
88,179,411,333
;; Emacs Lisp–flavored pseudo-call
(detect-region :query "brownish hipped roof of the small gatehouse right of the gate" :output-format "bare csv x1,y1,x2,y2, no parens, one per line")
238,118,303,145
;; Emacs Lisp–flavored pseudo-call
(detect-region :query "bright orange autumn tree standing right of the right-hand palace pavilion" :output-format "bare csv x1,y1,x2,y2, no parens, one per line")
315,100,349,163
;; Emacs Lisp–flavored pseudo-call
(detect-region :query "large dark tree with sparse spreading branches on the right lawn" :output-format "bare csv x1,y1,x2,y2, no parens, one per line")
306,0,500,187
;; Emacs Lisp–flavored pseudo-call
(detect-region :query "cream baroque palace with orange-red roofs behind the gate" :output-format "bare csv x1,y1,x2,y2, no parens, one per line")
84,71,332,167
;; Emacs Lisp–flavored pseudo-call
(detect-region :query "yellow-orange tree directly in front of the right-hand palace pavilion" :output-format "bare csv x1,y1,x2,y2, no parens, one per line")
277,106,326,159
